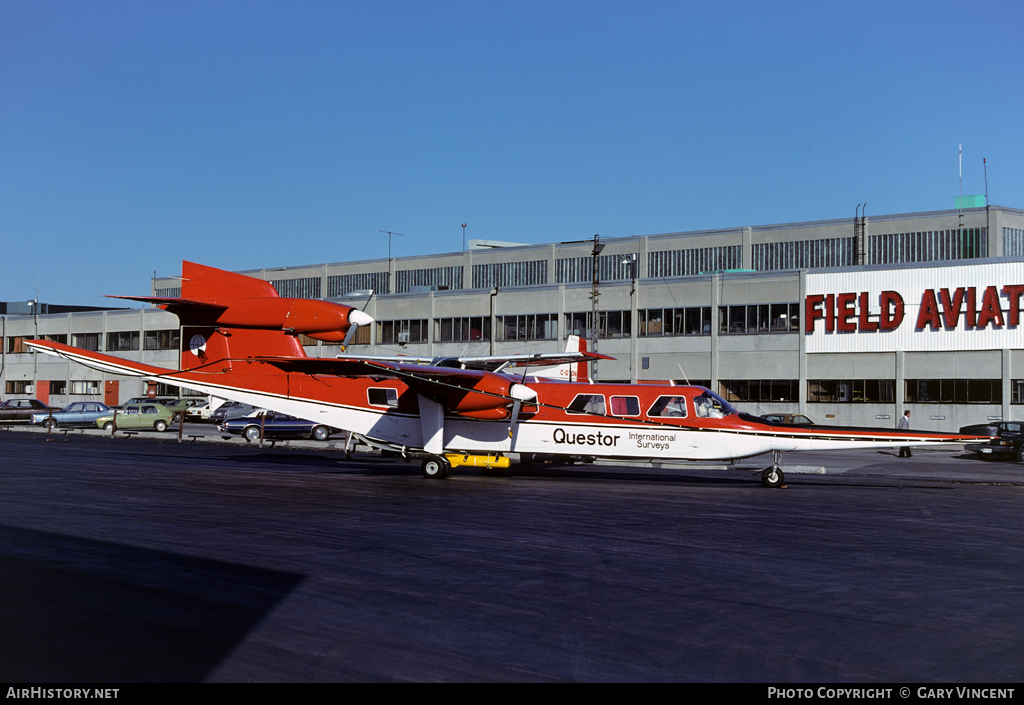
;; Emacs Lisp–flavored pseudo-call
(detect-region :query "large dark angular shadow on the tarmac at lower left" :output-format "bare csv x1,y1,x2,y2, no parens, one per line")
0,526,303,682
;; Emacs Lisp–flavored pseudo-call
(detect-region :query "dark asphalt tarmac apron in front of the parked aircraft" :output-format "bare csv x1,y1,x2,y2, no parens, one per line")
0,424,1024,680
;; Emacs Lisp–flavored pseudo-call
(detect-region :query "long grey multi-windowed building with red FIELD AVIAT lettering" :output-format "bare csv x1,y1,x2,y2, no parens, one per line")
6,206,1024,430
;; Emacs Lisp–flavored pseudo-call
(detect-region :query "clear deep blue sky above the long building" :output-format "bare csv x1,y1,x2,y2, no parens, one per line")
0,0,1024,305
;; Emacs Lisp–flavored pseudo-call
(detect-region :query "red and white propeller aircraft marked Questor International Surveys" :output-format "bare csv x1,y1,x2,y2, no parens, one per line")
26,261,977,487
